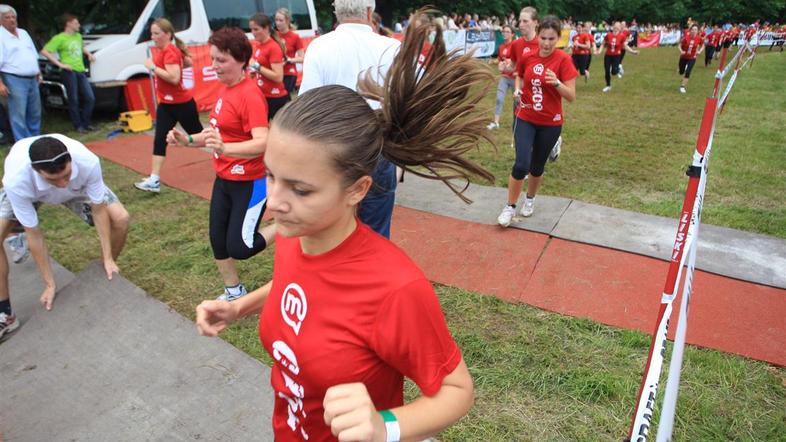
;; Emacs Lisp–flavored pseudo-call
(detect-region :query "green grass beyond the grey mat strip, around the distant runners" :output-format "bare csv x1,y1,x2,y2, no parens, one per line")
474,48,786,238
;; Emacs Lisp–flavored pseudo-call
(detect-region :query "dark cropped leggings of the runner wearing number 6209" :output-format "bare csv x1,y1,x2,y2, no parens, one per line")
510,118,562,180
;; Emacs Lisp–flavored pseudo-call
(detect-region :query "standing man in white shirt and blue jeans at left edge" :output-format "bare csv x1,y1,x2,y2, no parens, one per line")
0,5,41,140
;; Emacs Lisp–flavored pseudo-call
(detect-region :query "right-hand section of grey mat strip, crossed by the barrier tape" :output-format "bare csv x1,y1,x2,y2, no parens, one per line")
552,201,786,288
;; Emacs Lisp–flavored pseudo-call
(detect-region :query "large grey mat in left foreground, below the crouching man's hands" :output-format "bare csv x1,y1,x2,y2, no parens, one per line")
0,264,273,441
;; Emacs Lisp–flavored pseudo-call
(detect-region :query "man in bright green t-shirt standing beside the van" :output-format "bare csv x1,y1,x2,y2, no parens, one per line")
41,14,96,133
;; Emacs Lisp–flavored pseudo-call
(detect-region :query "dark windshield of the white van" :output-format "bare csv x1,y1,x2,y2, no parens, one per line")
80,0,148,35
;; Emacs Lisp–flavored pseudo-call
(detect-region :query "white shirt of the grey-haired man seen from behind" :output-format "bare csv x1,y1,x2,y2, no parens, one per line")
300,23,401,108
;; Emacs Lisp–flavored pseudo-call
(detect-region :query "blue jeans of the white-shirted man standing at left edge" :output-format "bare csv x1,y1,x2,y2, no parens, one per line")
3,74,41,141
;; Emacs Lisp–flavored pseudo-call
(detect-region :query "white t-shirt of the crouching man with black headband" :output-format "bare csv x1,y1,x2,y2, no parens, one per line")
3,134,106,228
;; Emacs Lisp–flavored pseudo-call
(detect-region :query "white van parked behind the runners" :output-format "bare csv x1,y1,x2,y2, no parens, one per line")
39,0,317,109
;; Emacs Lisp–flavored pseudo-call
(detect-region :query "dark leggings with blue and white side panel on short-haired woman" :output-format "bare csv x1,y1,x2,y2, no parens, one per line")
210,177,267,259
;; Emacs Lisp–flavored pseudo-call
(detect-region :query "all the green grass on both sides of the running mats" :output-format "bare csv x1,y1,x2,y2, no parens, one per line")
23,45,786,441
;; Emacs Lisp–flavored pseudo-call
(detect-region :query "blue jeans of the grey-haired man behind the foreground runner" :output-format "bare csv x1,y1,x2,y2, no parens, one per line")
358,158,396,239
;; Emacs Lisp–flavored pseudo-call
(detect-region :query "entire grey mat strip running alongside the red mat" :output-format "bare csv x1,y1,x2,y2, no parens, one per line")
396,174,786,288
